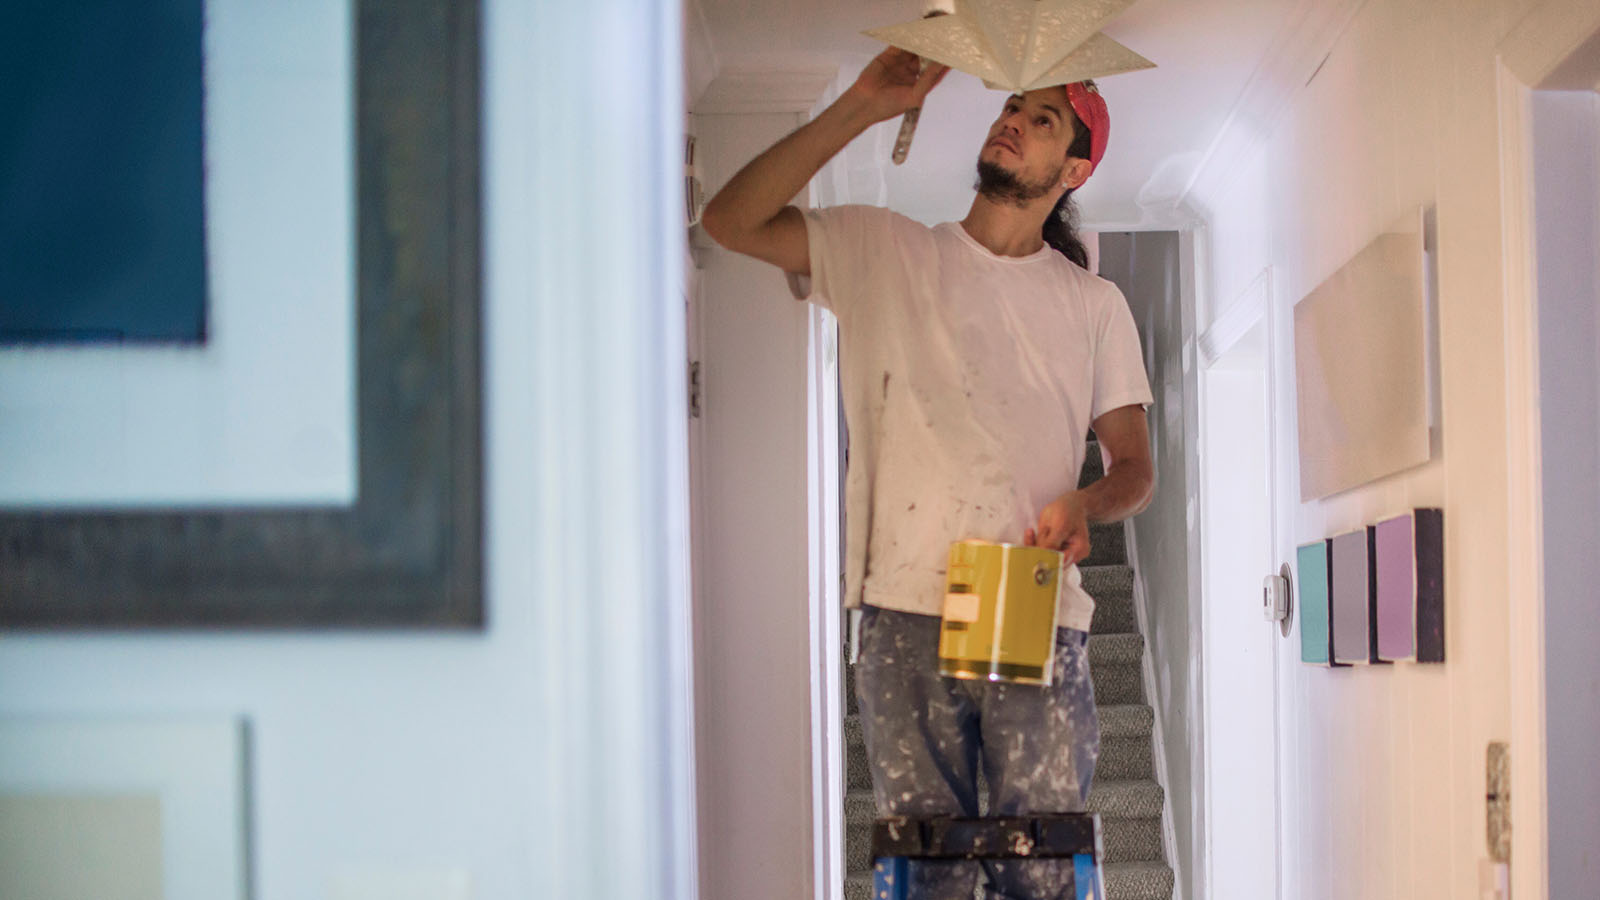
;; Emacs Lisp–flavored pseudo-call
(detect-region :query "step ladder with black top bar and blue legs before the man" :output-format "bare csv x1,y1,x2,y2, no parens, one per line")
872,814,1106,900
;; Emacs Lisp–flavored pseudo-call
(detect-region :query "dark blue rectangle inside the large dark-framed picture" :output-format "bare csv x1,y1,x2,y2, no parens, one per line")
0,0,206,344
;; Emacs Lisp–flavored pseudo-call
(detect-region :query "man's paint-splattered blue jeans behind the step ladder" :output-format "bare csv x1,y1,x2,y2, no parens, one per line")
856,607,1099,900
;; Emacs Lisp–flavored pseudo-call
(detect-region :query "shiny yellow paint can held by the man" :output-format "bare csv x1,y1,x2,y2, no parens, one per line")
939,541,1064,685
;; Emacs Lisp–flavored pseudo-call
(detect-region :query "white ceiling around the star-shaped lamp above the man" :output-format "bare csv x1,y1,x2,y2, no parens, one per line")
686,0,1306,229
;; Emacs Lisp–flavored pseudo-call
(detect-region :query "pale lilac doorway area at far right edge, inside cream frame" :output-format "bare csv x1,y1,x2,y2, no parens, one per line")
1512,85,1600,897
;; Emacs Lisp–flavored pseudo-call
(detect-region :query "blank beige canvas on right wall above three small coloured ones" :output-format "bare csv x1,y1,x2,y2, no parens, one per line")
1294,215,1430,501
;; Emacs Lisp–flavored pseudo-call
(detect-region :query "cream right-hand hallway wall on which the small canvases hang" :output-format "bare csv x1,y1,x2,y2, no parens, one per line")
1189,0,1531,900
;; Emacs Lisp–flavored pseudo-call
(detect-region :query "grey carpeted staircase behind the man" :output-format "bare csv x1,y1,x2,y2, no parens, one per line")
845,440,1173,900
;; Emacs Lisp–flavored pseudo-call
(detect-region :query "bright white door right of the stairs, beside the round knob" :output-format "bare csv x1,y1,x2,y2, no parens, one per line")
1195,315,1278,900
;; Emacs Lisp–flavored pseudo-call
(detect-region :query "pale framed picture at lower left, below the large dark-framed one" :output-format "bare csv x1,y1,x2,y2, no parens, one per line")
0,716,250,900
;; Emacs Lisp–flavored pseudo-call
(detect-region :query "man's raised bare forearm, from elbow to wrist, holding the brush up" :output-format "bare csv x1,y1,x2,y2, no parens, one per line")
701,91,874,242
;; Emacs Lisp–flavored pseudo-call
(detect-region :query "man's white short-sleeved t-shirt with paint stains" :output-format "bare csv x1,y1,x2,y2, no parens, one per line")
792,207,1152,631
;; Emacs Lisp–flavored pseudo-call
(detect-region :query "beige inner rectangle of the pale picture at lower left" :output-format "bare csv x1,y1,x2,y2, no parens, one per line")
0,793,162,900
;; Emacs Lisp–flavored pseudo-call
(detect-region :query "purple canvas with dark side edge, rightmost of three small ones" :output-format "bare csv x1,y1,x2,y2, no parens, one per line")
1373,509,1445,663
